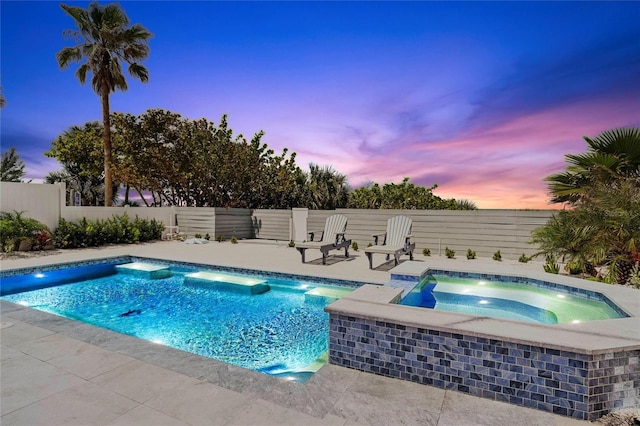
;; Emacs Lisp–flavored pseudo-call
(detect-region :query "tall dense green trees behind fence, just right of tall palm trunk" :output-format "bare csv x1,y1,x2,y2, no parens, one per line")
112,109,306,208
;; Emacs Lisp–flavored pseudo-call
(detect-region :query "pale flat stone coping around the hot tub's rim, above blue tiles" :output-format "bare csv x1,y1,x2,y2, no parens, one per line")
326,263,640,354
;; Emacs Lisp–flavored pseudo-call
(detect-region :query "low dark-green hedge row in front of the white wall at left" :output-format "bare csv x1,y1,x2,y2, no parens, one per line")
54,214,164,249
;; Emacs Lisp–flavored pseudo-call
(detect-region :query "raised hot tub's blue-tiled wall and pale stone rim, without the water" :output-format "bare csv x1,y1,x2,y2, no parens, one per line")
325,262,640,420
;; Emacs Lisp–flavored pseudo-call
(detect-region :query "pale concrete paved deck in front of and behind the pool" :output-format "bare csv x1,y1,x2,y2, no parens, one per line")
0,241,600,426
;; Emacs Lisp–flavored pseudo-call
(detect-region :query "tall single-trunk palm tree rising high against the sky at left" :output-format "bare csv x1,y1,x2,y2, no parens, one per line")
56,2,152,206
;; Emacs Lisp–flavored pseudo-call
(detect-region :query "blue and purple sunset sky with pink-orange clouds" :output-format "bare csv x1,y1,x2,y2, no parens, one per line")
0,0,640,209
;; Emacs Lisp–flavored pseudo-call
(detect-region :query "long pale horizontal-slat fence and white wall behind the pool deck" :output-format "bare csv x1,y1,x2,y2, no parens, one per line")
0,182,553,259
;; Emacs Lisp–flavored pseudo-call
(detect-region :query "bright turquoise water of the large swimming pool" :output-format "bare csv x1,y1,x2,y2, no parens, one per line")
2,265,353,381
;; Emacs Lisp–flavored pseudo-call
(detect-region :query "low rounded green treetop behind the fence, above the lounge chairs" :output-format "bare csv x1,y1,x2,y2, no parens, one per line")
348,178,475,210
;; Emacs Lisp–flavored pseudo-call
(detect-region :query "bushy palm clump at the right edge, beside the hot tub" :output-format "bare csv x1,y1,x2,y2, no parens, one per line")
532,128,640,284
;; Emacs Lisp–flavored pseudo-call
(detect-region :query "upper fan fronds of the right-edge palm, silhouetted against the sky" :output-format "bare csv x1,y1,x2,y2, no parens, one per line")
545,127,640,205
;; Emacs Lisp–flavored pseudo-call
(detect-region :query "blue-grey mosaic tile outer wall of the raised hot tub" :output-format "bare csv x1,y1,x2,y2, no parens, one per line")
329,314,640,420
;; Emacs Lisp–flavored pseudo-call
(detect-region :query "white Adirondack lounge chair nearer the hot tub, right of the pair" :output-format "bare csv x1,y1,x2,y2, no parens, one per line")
364,216,416,269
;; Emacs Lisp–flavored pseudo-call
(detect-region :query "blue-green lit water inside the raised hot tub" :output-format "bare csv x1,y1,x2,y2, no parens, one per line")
401,275,625,324
